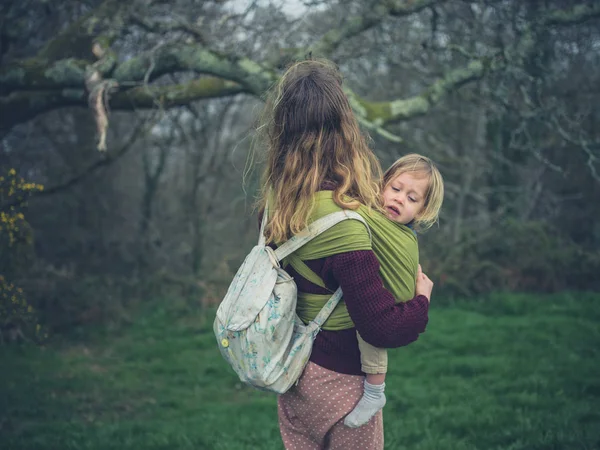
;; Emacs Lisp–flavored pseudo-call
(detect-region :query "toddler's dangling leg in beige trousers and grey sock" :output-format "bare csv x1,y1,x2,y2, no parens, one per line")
344,335,387,428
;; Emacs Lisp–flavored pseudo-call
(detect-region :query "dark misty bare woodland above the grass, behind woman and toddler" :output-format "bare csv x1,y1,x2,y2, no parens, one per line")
0,0,600,336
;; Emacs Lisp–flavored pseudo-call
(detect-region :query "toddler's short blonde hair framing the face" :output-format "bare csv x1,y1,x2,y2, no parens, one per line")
382,153,444,231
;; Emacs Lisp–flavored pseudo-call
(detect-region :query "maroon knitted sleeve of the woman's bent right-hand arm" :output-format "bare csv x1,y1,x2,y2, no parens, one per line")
326,250,429,348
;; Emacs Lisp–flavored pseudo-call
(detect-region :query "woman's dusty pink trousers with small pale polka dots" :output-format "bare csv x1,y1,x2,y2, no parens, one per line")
278,362,383,450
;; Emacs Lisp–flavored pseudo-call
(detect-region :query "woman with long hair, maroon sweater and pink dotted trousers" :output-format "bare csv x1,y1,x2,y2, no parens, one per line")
261,60,433,450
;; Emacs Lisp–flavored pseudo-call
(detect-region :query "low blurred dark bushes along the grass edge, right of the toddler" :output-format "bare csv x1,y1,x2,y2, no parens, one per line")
421,218,600,297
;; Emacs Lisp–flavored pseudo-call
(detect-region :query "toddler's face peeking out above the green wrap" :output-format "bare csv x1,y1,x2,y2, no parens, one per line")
383,172,429,225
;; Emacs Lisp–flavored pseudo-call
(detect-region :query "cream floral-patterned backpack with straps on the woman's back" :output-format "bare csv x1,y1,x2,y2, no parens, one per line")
213,210,368,394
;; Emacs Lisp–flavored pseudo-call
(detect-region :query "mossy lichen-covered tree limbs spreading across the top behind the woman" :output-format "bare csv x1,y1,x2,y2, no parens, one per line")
0,0,600,141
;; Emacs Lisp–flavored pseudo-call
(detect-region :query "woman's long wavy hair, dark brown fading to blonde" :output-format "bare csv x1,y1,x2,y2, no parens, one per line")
258,60,381,242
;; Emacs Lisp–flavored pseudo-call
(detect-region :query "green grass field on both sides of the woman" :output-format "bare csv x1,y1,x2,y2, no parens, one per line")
0,294,600,450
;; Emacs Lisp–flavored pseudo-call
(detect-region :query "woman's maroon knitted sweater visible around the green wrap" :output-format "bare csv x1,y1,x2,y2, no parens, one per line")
286,250,429,375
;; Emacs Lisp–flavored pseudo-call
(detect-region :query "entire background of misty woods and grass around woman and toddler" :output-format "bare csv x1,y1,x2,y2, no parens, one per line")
0,0,600,450
